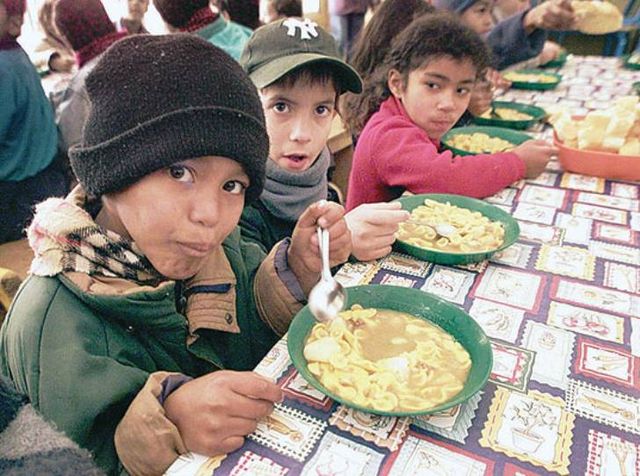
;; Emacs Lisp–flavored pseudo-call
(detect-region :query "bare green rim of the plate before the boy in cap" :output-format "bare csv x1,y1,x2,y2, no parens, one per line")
394,193,520,265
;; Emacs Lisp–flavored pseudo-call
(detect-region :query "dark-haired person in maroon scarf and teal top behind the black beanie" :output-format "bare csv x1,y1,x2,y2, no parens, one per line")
153,0,252,60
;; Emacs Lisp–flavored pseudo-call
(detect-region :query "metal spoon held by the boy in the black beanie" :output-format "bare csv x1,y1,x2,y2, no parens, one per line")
309,227,346,322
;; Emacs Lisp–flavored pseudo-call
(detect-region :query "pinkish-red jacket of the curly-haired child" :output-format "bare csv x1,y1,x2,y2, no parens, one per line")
347,96,525,210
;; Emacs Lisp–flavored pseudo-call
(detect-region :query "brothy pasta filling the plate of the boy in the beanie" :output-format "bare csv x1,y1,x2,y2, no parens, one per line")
304,305,471,412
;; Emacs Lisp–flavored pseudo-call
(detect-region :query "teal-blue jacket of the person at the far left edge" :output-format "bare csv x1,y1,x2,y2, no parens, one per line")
0,43,58,182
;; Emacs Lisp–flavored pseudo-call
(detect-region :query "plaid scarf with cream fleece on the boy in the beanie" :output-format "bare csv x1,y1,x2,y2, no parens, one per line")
27,186,164,284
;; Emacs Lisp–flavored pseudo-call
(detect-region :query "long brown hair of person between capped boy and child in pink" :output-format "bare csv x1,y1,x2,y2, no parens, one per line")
340,0,436,137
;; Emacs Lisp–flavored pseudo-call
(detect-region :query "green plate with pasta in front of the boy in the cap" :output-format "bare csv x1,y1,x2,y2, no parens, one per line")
394,194,520,265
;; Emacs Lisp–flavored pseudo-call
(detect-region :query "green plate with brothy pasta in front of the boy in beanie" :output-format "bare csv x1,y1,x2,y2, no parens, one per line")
287,285,493,416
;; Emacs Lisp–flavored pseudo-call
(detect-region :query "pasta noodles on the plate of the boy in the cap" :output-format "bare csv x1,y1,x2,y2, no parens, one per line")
397,199,505,253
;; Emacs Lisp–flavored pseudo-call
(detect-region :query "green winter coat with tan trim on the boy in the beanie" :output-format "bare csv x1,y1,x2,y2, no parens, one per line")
0,229,295,474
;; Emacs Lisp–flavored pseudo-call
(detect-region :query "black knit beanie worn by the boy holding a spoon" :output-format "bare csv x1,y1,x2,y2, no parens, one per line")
69,34,269,203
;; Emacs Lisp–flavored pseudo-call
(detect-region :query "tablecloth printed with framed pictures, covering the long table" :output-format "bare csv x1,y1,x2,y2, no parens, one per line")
169,56,640,476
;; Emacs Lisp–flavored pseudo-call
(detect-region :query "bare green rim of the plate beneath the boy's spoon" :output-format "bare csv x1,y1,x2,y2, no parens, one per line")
287,285,493,416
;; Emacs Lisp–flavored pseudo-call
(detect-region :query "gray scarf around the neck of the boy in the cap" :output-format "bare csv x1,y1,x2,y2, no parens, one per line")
260,147,331,221
